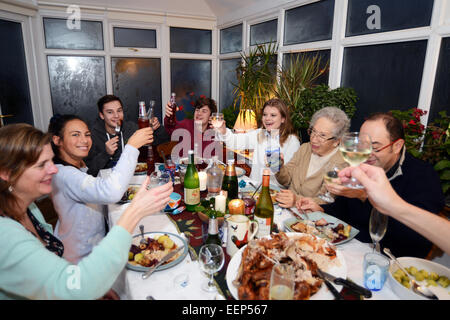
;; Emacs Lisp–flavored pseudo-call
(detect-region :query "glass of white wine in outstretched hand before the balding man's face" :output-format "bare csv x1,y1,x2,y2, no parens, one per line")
339,132,372,189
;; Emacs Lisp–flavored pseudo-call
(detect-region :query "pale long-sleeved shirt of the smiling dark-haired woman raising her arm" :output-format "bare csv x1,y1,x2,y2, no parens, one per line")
52,145,139,263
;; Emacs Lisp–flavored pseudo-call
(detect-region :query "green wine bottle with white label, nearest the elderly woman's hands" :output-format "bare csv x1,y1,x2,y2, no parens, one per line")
255,169,274,238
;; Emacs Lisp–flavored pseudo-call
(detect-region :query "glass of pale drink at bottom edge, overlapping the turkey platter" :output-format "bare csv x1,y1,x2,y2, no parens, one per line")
269,263,295,300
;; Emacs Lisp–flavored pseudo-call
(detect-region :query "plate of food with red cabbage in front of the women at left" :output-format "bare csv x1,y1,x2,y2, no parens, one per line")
127,232,188,272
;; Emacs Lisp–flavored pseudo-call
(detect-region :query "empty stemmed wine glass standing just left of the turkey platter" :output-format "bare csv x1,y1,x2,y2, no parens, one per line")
198,244,225,292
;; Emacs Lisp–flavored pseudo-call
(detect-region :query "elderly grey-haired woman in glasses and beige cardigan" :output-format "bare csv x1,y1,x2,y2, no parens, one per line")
275,107,350,208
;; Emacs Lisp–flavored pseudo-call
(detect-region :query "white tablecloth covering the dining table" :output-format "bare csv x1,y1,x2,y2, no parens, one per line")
107,172,399,300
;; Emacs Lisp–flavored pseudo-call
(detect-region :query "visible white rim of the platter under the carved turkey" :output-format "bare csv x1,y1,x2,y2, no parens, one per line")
226,232,347,300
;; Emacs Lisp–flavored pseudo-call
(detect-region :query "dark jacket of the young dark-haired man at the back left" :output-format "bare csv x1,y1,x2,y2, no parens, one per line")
84,119,170,176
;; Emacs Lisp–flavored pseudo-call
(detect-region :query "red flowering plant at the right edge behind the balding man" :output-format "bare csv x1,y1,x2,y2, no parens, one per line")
391,108,450,196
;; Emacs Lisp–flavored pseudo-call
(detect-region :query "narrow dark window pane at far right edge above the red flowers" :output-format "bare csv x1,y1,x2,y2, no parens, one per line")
428,38,450,121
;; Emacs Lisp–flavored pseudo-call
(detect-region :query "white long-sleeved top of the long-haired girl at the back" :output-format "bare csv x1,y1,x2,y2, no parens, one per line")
216,128,300,188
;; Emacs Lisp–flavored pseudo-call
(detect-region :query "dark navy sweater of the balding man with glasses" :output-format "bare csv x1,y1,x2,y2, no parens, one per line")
323,149,444,258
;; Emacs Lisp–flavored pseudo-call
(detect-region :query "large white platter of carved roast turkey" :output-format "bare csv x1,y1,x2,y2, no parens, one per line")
226,232,347,300
